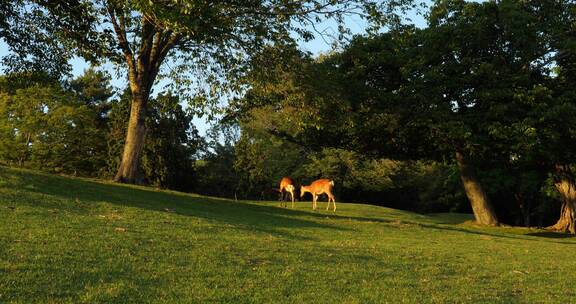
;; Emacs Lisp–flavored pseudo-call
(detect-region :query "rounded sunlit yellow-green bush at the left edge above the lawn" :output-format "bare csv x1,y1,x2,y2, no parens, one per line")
0,85,102,175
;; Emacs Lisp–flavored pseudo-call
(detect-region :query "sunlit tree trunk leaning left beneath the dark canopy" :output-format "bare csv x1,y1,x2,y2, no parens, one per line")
456,149,498,226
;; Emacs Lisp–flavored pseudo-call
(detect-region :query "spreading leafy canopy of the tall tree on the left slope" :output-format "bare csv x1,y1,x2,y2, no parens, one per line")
0,0,413,114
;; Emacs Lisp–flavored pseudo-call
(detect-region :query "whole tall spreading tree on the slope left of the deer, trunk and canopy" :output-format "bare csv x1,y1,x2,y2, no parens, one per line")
1,0,411,183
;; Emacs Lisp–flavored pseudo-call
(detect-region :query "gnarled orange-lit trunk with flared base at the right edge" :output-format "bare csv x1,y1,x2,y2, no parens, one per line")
548,165,576,234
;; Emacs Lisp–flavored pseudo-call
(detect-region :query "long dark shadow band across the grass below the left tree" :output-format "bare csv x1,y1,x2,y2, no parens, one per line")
0,167,346,239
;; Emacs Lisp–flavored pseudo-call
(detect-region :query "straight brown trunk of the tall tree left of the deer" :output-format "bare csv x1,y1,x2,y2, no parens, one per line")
114,94,148,184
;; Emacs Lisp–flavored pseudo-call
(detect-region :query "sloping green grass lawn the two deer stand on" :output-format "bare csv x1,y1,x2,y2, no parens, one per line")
0,167,576,303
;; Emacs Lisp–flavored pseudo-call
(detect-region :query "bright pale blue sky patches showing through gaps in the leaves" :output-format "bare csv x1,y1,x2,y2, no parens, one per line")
0,7,424,136
